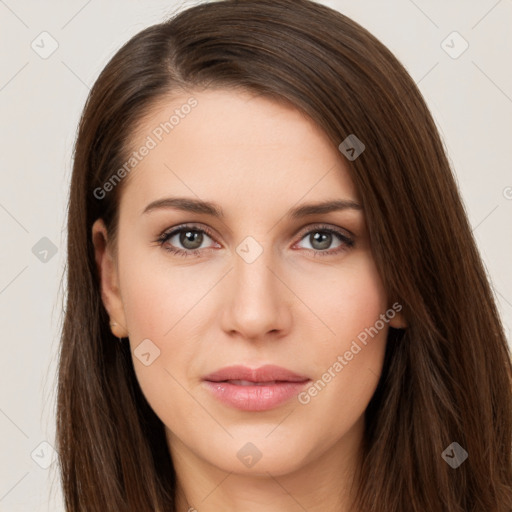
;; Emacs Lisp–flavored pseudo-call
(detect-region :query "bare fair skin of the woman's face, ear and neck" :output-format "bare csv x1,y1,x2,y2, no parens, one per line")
92,89,404,512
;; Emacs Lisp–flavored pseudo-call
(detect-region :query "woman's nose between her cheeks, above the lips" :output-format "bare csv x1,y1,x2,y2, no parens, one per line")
221,245,293,341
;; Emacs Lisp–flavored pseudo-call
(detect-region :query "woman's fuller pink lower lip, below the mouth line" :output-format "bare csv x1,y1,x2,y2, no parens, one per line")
204,380,309,411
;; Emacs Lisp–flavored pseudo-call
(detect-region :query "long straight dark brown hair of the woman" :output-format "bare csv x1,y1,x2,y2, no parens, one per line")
57,0,512,512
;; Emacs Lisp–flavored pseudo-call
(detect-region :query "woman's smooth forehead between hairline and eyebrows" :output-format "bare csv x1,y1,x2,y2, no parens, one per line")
121,89,358,218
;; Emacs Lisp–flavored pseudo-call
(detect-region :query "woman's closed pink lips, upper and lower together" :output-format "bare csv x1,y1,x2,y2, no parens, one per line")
203,365,311,411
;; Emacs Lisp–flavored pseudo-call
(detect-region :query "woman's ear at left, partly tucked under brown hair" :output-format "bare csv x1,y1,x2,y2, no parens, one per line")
92,219,128,338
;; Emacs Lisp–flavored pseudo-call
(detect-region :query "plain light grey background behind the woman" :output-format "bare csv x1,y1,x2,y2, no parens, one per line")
0,0,512,512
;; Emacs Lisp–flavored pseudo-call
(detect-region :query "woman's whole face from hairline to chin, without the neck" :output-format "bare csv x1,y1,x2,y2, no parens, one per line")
93,90,399,475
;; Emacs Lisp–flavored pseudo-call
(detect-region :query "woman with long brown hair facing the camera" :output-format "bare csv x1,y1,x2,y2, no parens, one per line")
57,0,512,512
